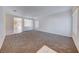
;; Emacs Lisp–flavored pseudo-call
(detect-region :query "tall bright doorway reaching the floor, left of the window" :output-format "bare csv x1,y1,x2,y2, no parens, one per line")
14,17,22,33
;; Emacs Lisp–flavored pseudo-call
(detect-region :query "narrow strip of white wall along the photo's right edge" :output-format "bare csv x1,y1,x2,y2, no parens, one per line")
72,8,79,51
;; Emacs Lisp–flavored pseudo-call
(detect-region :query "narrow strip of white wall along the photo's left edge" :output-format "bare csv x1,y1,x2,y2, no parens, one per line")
0,7,5,48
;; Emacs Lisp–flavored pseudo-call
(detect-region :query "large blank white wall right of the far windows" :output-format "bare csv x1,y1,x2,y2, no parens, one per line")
38,11,72,37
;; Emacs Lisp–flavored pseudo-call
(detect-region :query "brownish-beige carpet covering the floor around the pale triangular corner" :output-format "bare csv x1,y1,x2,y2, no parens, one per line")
1,31,78,53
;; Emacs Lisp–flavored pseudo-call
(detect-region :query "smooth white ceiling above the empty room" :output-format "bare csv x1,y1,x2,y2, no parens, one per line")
4,6,72,17
